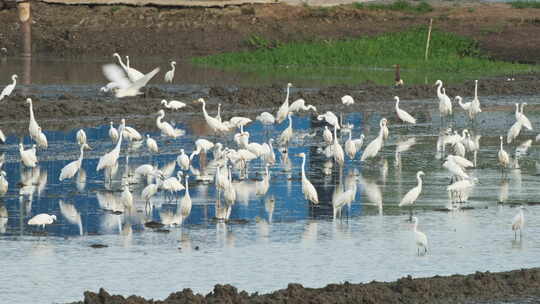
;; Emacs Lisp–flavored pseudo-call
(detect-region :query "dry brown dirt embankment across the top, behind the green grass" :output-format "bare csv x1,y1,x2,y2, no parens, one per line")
0,2,540,62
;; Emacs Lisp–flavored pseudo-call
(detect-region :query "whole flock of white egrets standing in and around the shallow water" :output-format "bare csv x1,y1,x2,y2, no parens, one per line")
0,53,532,254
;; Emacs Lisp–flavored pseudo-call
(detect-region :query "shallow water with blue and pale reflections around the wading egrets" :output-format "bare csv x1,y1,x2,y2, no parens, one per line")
0,97,540,303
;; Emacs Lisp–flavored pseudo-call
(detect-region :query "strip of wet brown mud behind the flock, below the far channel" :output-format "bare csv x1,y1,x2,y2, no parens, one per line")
0,73,540,134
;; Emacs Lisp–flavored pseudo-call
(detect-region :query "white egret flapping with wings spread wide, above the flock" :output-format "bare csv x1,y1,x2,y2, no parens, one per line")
103,64,159,98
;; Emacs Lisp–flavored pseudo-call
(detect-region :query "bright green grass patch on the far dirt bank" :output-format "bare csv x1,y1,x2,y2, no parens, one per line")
192,27,538,83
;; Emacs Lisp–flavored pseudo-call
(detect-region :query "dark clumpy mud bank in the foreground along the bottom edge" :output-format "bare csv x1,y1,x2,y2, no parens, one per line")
74,268,540,304
